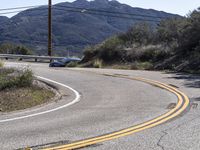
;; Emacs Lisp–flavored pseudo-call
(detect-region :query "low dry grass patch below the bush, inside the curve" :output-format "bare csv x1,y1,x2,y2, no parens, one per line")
0,86,55,112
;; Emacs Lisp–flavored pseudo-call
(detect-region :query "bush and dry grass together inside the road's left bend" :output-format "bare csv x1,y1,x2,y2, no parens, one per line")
0,67,55,112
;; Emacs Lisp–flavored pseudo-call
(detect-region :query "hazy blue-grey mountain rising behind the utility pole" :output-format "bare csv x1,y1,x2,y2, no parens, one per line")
0,0,178,55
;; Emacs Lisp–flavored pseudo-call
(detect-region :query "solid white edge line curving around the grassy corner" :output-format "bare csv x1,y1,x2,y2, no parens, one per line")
0,76,81,123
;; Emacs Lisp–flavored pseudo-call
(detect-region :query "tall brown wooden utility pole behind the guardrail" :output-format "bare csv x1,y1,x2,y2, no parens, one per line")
48,0,52,56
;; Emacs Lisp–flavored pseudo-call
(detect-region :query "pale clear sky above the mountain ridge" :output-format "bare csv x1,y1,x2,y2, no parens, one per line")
0,0,200,17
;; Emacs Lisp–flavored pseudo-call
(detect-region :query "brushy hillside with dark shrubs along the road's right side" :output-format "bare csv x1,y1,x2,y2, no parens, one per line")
81,8,200,73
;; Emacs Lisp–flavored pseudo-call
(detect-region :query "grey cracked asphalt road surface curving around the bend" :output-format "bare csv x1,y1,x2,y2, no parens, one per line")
0,63,200,150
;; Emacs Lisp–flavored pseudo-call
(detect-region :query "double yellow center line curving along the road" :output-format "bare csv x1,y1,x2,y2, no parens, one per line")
41,74,189,150
